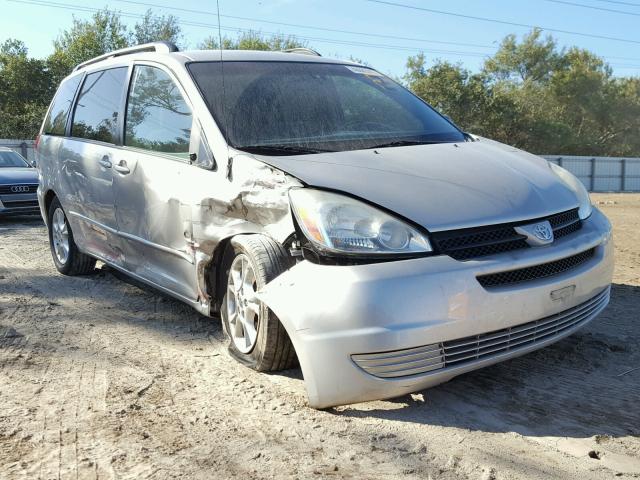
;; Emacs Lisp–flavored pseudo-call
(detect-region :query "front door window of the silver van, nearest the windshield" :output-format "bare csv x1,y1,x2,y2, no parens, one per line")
124,65,192,158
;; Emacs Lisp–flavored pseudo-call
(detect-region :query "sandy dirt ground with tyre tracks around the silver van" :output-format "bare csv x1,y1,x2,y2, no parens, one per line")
0,194,640,480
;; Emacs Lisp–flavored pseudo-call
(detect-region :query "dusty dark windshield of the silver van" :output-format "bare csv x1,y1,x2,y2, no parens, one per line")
188,61,464,155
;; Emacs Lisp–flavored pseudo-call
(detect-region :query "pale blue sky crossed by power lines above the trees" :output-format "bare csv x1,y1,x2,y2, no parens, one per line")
0,0,640,76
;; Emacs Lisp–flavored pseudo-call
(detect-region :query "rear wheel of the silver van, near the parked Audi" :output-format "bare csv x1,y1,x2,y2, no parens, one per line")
47,197,96,275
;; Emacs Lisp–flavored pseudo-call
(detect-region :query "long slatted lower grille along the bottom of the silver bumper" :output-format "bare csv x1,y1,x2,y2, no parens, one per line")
351,288,610,378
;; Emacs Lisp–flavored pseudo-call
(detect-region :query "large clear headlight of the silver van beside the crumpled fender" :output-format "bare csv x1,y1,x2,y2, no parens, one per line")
289,188,431,255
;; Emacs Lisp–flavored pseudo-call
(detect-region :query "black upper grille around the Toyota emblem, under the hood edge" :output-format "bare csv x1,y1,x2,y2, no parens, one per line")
431,208,582,260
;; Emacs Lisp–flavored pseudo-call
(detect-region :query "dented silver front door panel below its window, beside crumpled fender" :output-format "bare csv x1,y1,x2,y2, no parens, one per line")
114,150,199,301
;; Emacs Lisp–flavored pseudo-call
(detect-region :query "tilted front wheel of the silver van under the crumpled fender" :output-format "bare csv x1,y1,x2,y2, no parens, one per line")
220,235,296,372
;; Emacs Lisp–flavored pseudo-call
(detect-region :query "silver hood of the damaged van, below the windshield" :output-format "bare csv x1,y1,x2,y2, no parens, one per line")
249,139,578,232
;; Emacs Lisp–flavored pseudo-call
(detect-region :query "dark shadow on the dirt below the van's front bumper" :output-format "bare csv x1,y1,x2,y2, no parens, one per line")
332,284,640,437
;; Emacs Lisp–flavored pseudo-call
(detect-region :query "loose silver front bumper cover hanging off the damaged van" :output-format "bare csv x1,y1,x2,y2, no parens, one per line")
260,209,613,408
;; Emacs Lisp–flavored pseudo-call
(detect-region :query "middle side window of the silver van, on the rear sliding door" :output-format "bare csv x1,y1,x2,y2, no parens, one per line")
71,67,127,143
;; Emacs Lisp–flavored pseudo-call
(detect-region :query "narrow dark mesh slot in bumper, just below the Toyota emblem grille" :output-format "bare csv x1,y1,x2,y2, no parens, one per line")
476,248,596,287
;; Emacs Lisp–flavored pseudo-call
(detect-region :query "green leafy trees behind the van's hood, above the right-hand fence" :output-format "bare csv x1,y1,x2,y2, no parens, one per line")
404,30,640,156
